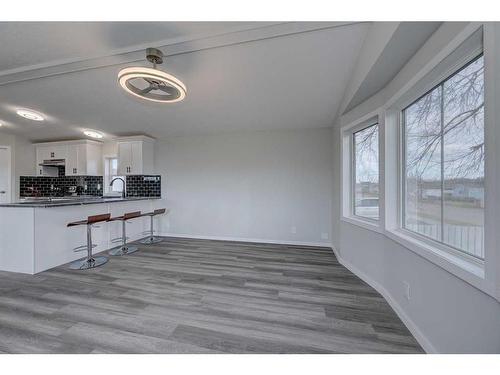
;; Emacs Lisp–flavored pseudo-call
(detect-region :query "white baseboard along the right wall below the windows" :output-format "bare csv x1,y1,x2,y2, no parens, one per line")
331,245,438,354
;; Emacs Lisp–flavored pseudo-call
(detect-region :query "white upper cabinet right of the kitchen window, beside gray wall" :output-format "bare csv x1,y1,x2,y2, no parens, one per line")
117,136,154,176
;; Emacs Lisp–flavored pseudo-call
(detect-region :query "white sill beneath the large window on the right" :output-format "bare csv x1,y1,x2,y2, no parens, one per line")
385,229,497,298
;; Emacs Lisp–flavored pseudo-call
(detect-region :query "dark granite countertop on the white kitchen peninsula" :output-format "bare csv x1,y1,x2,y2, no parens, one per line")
0,197,161,208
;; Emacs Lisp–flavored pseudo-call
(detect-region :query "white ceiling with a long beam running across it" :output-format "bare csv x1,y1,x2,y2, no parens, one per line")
0,22,369,141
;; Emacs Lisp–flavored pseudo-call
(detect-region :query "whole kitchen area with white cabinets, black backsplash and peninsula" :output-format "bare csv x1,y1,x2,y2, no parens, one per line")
0,136,161,274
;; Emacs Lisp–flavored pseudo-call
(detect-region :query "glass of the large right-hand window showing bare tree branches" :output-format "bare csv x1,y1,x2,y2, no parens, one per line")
402,55,484,259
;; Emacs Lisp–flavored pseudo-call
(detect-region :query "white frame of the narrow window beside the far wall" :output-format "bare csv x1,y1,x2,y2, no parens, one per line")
341,113,383,232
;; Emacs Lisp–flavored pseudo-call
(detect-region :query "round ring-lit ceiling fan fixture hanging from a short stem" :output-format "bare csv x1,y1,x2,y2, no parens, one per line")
118,48,186,103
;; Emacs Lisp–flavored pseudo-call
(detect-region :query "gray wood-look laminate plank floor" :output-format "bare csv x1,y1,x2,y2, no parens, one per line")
0,237,422,353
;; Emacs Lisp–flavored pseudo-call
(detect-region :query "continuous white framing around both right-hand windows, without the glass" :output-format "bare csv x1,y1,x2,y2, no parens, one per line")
340,23,500,301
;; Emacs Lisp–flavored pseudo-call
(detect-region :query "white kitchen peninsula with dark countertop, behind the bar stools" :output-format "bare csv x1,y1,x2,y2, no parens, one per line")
0,197,160,274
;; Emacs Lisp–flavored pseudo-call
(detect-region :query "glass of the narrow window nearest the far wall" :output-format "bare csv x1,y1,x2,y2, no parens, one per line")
352,124,379,220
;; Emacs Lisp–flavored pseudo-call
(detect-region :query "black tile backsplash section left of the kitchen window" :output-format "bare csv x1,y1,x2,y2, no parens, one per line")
19,176,103,197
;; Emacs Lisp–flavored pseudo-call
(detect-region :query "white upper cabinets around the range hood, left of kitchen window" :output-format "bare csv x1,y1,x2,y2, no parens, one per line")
35,140,102,176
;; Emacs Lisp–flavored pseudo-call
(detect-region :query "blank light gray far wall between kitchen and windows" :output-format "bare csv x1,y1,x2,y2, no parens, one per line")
155,129,332,246
